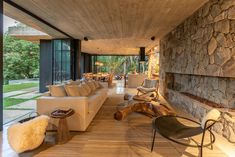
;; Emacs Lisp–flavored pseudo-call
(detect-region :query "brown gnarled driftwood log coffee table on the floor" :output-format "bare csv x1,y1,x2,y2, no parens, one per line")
114,101,175,121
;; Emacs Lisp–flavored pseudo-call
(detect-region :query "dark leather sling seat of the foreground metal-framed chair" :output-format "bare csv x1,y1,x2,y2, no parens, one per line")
153,116,203,139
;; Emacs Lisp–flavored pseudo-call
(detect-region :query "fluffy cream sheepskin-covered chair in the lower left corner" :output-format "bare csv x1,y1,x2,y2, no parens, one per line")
7,115,49,153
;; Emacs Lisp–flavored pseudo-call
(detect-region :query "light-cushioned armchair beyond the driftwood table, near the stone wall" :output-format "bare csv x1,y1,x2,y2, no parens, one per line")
137,79,159,100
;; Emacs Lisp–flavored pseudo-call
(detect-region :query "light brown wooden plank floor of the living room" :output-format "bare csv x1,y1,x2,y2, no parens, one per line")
0,83,226,157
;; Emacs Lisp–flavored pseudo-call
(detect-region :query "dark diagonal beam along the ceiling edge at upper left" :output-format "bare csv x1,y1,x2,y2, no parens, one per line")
3,0,73,39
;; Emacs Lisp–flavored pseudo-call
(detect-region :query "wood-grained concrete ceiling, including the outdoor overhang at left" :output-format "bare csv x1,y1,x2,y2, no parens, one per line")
4,0,208,54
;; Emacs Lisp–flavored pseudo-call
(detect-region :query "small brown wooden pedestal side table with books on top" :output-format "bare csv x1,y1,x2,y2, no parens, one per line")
51,109,74,144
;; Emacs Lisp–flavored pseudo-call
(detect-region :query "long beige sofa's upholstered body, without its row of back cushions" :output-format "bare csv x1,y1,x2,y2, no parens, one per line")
37,83,108,131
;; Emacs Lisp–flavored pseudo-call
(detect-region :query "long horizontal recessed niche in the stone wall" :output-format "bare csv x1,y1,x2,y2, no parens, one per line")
170,74,235,108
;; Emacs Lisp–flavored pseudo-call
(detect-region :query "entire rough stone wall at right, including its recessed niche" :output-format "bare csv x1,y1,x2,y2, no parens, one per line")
159,0,235,142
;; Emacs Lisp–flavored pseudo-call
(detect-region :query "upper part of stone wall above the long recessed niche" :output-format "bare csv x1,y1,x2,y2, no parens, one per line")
160,0,235,80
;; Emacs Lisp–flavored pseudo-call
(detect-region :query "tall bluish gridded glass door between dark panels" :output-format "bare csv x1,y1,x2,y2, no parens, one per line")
53,39,71,84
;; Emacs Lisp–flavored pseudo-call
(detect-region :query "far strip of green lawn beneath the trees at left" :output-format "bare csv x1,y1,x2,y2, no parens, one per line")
3,83,38,93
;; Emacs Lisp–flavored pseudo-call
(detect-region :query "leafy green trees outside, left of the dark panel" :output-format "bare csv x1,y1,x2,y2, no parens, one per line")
3,33,39,84
